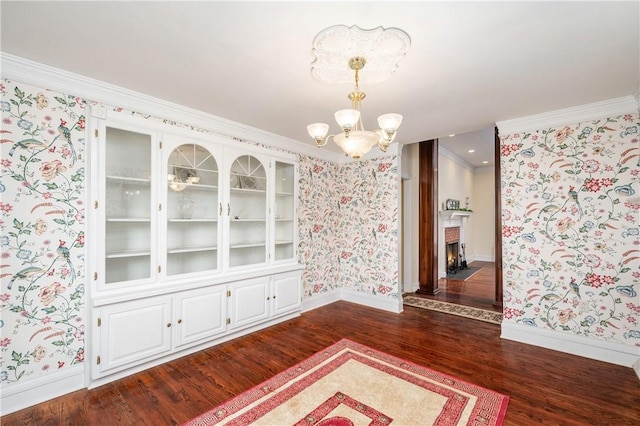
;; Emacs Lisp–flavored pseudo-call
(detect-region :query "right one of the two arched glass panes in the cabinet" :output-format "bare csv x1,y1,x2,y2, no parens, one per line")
227,155,267,267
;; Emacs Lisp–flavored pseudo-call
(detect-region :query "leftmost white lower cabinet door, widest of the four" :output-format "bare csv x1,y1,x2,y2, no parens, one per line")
94,296,173,376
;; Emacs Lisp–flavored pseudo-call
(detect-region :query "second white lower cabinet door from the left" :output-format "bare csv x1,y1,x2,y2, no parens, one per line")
174,285,227,347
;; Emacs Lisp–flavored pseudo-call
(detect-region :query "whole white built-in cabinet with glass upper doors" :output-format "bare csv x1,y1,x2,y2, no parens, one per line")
88,113,302,383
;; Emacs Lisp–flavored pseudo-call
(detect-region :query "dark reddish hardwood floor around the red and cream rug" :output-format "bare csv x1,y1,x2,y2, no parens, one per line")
0,302,640,426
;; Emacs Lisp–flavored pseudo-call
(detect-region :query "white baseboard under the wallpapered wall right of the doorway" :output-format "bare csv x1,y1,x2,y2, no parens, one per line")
500,322,640,368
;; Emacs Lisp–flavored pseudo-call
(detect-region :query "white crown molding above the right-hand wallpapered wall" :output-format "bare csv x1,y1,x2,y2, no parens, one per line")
496,94,639,135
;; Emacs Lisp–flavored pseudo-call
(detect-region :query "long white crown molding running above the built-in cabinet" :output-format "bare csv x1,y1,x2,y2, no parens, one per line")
0,52,343,163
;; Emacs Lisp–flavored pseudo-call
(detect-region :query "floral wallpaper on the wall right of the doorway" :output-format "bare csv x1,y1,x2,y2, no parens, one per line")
501,114,640,346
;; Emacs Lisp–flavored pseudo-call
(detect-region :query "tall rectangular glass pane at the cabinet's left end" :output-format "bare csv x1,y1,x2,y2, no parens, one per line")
104,127,155,284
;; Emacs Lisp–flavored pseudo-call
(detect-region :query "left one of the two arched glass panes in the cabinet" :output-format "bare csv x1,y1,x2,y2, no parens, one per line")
166,144,221,275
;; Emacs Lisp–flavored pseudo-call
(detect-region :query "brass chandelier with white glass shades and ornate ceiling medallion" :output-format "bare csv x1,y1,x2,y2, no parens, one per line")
307,25,410,160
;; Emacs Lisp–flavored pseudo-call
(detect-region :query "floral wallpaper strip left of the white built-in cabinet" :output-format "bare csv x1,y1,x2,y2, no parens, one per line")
0,80,85,385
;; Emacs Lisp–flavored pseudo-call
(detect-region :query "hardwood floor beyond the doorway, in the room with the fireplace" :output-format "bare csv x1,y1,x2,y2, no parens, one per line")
413,261,502,312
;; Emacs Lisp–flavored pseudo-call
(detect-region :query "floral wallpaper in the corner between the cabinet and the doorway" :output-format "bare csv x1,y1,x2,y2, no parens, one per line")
298,156,399,298
